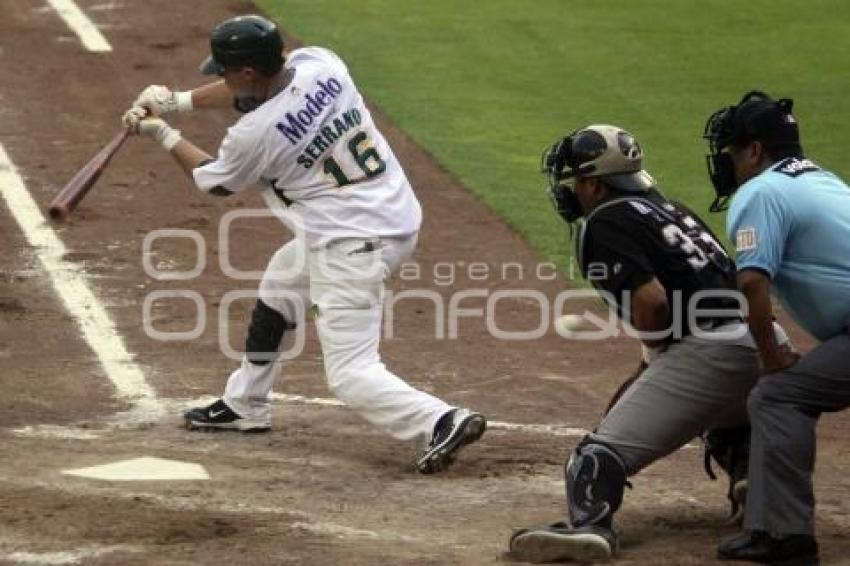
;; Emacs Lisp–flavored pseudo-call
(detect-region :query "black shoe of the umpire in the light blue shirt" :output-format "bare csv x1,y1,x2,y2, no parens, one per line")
717,531,819,566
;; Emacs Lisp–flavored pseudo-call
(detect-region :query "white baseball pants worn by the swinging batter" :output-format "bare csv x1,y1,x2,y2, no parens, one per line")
224,235,453,444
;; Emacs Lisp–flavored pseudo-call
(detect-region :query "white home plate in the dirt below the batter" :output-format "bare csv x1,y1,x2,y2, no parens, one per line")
62,456,210,481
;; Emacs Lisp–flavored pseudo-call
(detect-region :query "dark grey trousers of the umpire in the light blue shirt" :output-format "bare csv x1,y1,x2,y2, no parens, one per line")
744,334,850,535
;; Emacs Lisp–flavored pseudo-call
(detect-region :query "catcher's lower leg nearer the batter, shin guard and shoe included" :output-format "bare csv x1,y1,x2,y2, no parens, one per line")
510,436,628,562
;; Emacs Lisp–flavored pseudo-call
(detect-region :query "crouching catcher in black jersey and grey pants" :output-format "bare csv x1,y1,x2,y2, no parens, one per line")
510,125,788,562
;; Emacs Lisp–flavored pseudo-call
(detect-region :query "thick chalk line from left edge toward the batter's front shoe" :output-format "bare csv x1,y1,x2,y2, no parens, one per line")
0,144,158,416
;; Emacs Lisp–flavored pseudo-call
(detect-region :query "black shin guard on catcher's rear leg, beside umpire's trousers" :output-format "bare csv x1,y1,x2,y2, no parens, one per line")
703,426,750,523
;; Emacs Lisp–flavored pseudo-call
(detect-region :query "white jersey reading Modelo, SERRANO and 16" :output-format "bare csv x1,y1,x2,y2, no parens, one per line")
193,47,422,243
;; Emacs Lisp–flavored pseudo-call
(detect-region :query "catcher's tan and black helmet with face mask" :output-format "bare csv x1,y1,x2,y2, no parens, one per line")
541,124,655,224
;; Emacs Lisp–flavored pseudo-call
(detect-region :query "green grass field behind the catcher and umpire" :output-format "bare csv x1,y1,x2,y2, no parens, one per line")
259,0,850,266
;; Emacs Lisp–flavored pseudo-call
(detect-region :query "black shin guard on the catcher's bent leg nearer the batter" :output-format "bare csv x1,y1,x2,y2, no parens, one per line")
564,436,628,529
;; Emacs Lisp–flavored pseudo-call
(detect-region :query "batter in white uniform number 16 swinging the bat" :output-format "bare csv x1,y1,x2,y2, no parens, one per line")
124,16,486,473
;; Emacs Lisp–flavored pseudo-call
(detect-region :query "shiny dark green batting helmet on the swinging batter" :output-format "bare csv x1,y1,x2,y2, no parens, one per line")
200,15,283,75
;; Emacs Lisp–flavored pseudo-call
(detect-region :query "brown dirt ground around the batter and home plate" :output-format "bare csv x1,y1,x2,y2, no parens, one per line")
0,0,850,565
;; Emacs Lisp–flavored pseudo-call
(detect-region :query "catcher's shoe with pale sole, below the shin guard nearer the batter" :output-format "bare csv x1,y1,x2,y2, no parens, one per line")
510,522,617,563
